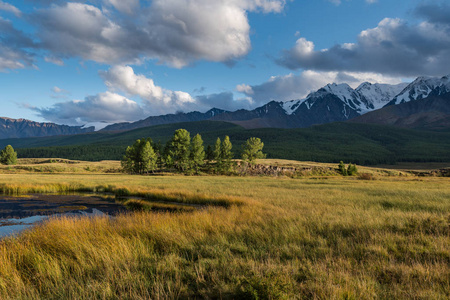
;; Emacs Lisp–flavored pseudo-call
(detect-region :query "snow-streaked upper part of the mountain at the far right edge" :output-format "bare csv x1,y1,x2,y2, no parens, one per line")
387,75,450,105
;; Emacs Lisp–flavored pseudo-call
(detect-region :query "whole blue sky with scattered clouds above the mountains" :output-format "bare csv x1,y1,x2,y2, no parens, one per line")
0,0,450,126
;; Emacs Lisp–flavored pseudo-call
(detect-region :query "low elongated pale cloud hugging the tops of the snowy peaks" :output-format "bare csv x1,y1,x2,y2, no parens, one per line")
236,71,401,106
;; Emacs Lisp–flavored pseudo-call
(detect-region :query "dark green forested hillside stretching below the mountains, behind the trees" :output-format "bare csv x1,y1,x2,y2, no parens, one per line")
0,121,450,165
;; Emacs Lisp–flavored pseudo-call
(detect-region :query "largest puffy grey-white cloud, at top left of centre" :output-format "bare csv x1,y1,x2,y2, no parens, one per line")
32,0,285,68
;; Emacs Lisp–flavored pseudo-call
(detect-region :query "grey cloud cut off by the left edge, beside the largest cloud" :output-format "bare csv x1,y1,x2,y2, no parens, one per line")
0,17,35,72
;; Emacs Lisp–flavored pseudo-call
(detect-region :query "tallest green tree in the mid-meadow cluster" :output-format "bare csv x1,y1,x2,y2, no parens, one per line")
169,129,191,172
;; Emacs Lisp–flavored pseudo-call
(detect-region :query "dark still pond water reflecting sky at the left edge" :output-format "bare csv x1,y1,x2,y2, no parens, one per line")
0,194,127,238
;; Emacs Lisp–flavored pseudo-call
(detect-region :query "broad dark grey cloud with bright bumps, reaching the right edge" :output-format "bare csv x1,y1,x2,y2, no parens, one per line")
278,4,450,77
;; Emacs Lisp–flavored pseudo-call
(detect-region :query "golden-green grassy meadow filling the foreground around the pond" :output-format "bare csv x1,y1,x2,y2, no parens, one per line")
0,160,450,299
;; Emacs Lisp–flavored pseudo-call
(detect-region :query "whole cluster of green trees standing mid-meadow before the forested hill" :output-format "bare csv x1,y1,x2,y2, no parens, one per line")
121,129,265,174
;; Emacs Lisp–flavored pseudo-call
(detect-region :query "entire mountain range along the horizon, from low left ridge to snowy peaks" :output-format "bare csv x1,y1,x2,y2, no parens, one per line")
0,76,450,139
